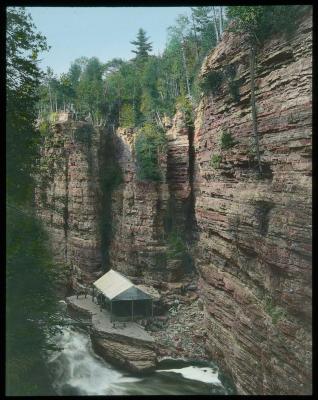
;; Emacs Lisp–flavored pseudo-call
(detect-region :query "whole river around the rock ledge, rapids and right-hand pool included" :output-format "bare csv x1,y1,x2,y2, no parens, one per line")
47,327,234,396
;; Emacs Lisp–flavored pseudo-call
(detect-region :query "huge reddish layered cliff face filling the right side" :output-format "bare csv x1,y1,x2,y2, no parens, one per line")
194,10,312,394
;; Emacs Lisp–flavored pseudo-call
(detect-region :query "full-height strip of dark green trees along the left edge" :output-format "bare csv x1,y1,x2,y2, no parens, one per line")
6,8,61,396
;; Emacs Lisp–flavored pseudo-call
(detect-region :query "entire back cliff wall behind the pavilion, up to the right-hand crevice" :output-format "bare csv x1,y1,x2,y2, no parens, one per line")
36,111,193,290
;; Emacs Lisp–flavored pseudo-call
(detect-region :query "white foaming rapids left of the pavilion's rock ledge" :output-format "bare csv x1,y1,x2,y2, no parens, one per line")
48,328,140,395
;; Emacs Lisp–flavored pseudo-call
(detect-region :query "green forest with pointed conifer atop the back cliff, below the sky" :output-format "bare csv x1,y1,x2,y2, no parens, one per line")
38,7,226,127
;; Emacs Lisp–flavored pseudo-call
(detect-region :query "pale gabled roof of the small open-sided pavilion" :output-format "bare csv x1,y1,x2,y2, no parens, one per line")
93,269,152,300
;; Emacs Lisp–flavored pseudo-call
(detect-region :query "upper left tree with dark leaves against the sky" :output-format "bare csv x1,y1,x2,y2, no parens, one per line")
6,7,47,203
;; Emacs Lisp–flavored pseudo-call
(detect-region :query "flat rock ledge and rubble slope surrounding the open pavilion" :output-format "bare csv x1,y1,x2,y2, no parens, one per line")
66,283,208,373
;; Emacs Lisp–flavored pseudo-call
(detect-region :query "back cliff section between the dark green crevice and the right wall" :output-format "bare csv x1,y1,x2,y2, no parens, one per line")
109,112,195,283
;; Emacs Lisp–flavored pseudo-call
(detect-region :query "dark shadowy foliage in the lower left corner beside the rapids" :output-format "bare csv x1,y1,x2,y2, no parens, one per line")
6,203,57,396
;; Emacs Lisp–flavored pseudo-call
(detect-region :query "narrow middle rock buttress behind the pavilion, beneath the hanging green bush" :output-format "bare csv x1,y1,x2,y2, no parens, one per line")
109,128,169,281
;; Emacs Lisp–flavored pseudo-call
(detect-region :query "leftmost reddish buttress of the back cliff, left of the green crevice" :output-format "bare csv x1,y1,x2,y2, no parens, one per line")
36,115,101,289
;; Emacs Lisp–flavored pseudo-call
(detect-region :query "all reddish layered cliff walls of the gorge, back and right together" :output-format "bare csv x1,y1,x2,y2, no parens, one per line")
37,8,312,394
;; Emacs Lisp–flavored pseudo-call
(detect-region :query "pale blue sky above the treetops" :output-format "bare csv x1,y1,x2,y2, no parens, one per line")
26,7,190,75
